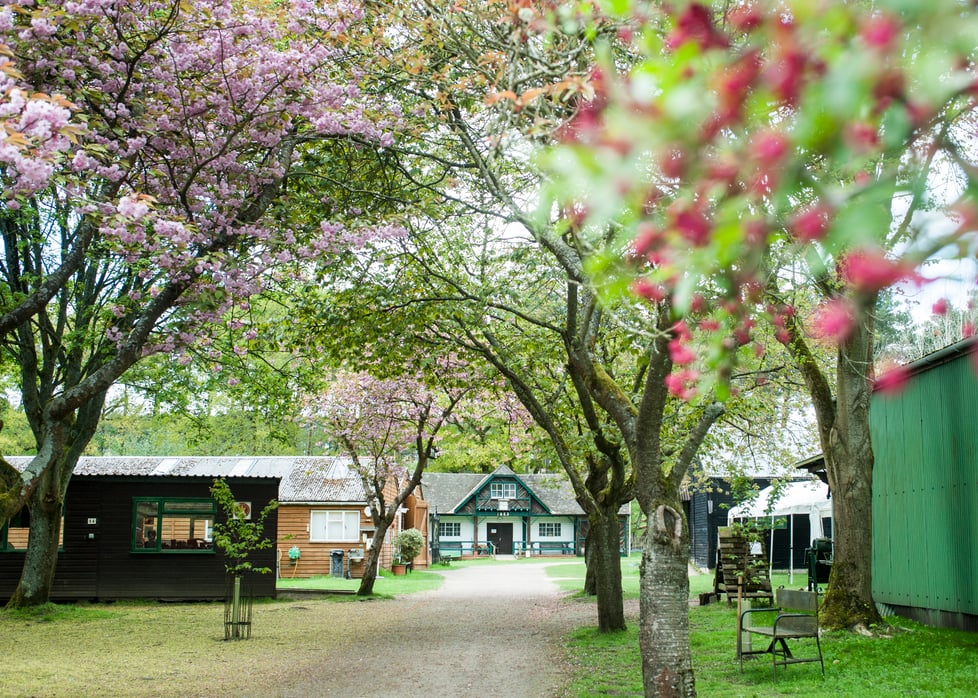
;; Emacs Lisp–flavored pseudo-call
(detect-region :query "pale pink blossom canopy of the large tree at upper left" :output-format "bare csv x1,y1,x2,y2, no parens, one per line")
0,0,402,362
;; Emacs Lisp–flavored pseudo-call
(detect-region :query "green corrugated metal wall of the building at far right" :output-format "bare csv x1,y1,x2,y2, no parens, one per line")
870,356,978,614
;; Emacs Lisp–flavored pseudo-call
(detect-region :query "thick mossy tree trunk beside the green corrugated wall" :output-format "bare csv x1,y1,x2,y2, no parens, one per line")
822,326,883,628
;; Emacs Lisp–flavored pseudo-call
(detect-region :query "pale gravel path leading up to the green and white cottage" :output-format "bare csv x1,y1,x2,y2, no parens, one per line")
279,563,595,698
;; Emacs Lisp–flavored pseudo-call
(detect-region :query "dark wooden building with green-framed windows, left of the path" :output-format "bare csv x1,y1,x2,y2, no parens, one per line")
0,458,280,601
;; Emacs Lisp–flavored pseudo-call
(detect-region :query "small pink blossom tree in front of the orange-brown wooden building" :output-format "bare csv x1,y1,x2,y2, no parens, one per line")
307,373,475,596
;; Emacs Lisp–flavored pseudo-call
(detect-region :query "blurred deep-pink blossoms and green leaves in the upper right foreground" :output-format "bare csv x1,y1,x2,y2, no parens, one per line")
553,0,978,396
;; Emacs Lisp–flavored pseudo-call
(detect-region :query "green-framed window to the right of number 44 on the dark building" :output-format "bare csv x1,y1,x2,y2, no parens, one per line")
131,497,217,554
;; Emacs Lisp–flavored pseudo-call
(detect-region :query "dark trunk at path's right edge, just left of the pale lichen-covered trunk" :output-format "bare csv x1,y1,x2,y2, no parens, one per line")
585,507,625,633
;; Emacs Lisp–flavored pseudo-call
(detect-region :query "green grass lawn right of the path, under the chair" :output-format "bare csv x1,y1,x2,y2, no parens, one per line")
548,558,978,698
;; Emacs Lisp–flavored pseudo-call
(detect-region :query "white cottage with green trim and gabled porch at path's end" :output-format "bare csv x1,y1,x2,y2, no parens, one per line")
421,465,630,561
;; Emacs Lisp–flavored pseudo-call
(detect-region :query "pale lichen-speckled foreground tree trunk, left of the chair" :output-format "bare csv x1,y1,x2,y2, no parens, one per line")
639,502,696,698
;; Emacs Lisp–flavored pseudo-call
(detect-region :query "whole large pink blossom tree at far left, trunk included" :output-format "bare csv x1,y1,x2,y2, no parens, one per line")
0,0,396,606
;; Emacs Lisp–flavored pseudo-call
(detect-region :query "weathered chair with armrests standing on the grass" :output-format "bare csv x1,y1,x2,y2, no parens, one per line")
737,587,825,681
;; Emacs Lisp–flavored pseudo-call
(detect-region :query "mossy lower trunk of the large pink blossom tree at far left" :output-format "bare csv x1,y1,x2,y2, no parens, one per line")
7,464,70,608
